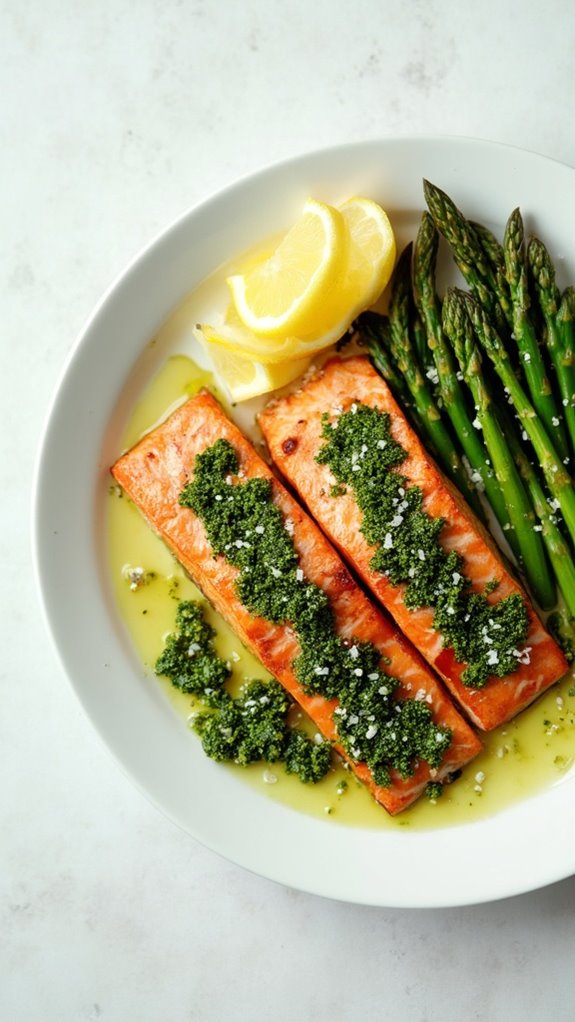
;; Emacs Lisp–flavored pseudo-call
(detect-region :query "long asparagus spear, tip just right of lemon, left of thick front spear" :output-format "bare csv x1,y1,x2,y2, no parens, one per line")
413,213,520,543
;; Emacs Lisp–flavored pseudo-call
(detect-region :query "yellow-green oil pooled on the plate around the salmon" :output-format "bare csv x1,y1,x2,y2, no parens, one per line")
108,356,575,830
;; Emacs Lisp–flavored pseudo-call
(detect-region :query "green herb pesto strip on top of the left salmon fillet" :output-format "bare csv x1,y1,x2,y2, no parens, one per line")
180,439,451,786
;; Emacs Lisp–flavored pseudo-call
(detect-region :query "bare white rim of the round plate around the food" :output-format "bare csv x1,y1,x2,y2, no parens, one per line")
35,139,575,907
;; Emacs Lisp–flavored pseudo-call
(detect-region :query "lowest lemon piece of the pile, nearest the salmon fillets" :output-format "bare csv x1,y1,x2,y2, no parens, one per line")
194,328,309,403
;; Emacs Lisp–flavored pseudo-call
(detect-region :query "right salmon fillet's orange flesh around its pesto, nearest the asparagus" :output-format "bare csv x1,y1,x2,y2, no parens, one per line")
259,356,568,731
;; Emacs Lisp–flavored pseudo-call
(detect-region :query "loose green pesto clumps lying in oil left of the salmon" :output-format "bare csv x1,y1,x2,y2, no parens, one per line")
155,600,331,784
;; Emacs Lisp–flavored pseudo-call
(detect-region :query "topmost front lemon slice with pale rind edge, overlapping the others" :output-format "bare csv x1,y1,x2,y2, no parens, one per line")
228,199,347,337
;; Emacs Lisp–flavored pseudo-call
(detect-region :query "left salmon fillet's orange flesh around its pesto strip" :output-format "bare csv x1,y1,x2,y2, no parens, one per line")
111,391,481,815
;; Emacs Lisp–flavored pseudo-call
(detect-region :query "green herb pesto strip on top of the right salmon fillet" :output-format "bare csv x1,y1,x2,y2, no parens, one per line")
317,403,529,688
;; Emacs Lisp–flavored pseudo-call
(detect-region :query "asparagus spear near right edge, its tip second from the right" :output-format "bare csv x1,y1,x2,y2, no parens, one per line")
527,238,575,460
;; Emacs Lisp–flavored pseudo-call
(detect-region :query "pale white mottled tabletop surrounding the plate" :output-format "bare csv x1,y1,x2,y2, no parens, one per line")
6,0,575,1022
